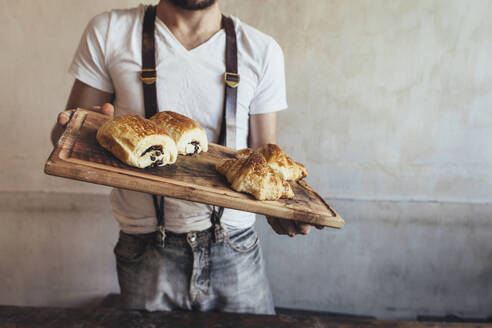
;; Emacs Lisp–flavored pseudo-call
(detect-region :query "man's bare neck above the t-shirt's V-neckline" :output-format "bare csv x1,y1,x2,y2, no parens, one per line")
157,0,222,50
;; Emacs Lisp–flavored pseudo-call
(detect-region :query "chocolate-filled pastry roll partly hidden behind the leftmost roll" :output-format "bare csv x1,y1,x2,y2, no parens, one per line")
150,111,208,155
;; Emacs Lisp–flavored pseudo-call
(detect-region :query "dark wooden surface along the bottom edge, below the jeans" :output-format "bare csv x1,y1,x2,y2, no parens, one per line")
0,306,492,328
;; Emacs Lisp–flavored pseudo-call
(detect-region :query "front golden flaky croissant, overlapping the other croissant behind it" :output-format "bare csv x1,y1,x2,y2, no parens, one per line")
216,151,294,200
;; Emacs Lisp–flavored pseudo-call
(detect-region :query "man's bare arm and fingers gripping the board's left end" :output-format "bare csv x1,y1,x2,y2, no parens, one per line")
51,80,114,145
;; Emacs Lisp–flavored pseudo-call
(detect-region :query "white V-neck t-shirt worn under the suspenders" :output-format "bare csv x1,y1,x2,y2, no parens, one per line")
70,5,287,233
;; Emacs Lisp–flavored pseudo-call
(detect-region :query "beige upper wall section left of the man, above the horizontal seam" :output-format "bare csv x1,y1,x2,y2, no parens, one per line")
0,0,148,192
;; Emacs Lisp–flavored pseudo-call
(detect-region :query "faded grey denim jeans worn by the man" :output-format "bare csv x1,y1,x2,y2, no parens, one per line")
114,227,275,314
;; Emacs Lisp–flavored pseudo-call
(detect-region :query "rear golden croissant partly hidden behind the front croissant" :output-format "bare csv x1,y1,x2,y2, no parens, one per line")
236,144,307,180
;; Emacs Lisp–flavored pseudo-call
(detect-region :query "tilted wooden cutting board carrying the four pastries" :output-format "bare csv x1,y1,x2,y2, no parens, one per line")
45,109,344,228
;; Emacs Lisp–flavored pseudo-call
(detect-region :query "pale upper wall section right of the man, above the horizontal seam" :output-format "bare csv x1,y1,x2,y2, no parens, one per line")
224,0,492,203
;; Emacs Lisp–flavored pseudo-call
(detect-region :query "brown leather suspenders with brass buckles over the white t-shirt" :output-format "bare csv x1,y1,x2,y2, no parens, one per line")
140,6,240,241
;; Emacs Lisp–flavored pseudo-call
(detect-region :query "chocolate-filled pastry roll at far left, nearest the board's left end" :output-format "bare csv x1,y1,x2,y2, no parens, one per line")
96,115,178,168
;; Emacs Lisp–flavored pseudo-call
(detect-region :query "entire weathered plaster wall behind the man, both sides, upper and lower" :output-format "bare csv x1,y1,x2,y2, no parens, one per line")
0,0,492,318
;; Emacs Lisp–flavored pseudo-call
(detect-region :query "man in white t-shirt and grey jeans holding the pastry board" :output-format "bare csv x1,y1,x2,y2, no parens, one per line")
53,0,311,314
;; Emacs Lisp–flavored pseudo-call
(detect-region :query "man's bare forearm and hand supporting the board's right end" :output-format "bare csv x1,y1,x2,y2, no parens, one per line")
249,112,311,237
